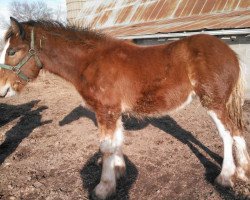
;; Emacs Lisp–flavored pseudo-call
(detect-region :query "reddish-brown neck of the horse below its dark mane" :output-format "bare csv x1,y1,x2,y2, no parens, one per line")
39,30,106,86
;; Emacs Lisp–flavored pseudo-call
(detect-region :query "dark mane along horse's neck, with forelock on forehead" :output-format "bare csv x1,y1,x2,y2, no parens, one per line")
5,20,109,41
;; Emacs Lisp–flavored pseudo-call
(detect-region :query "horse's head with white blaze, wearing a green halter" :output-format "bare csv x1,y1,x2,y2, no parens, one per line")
0,17,43,97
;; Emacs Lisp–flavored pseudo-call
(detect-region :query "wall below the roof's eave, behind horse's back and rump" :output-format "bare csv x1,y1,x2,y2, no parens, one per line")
134,36,250,100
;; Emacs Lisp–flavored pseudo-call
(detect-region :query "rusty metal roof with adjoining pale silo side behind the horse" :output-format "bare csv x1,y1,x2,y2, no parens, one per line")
66,0,250,37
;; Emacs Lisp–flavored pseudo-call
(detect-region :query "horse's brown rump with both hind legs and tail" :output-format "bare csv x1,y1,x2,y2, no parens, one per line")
185,35,250,186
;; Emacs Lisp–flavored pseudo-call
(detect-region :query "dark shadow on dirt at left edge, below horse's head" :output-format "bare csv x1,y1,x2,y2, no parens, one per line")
0,101,52,165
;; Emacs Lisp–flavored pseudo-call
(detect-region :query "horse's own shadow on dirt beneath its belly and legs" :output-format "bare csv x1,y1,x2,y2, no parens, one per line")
59,106,245,199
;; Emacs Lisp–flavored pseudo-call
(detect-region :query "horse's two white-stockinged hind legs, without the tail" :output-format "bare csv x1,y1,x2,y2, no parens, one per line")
208,104,250,186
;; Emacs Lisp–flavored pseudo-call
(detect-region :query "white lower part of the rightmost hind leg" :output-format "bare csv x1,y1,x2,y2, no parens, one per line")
233,136,250,181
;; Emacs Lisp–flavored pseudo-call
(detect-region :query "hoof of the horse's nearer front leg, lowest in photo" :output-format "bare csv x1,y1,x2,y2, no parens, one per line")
91,183,116,200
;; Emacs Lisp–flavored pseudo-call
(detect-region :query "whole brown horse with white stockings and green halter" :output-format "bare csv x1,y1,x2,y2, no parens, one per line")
0,18,250,199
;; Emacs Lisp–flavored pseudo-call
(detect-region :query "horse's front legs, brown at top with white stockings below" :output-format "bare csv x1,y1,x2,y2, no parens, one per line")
93,111,125,199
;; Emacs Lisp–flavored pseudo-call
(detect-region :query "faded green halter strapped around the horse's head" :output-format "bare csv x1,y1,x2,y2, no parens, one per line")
0,29,43,82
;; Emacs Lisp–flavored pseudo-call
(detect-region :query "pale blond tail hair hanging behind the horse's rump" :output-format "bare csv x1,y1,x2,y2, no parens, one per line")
227,62,245,130
